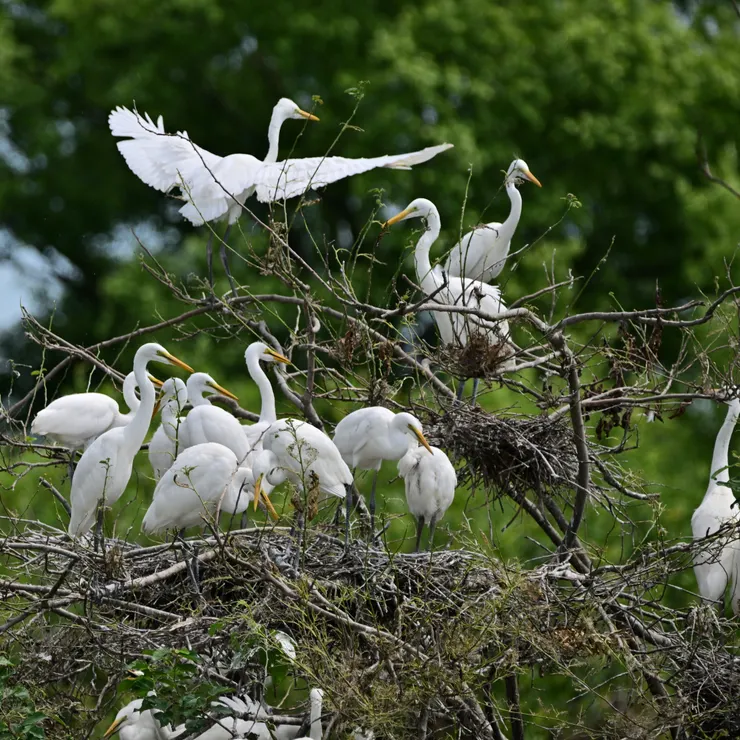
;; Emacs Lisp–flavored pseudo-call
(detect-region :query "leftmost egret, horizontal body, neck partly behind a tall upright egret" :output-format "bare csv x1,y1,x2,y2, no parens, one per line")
31,372,162,451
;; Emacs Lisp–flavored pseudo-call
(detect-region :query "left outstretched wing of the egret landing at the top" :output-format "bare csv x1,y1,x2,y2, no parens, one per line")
108,106,222,193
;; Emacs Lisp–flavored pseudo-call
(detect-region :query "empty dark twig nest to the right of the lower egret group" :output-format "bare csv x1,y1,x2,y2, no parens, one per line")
424,403,578,492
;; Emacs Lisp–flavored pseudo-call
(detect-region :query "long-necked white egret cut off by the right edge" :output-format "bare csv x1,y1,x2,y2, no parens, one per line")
691,398,740,614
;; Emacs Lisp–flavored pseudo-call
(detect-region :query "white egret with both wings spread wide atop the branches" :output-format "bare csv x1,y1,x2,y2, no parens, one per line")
108,99,452,225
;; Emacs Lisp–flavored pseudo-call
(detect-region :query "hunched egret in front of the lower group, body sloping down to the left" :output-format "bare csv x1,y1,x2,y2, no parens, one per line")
142,442,277,534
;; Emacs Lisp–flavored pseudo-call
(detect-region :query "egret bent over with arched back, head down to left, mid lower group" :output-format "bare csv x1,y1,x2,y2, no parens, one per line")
252,419,353,541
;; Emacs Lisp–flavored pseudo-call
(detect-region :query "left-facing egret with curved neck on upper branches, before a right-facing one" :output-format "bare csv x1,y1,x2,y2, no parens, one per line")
385,198,509,346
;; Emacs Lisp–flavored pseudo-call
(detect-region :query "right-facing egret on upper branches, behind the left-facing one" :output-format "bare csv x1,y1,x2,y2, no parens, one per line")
445,159,542,283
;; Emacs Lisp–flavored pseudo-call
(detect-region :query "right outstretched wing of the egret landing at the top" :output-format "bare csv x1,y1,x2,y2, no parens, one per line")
249,144,452,203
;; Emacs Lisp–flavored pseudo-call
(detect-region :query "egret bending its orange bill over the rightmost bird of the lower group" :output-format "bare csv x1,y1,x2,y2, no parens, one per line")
334,406,431,532
